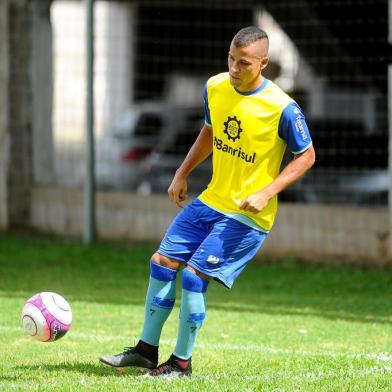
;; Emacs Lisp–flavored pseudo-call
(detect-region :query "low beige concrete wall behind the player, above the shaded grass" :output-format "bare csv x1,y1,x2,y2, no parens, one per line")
31,187,388,265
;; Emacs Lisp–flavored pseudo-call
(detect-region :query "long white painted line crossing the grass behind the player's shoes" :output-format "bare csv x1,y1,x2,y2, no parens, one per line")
0,325,392,362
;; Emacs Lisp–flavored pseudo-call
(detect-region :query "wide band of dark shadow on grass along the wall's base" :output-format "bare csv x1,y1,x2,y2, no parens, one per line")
0,236,392,324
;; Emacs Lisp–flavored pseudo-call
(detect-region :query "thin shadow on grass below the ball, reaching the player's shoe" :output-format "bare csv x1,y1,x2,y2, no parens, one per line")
14,362,145,377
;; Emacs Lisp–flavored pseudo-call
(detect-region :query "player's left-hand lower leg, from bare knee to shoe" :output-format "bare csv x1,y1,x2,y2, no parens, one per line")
100,253,180,368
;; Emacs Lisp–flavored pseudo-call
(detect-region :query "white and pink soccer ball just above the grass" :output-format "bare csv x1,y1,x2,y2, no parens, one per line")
22,291,72,342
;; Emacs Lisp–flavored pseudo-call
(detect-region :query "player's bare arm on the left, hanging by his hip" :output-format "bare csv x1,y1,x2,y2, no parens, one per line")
167,124,212,208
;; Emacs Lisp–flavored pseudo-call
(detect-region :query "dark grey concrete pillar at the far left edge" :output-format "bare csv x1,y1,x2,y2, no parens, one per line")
0,0,31,228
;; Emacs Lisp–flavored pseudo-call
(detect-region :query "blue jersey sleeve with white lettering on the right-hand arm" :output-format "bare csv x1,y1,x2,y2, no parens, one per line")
278,102,312,154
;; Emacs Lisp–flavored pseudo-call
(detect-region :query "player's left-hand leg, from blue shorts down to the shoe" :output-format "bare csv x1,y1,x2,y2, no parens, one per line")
100,199,213,368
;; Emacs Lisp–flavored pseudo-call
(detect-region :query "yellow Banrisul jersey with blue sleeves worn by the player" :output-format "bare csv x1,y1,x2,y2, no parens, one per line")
199,72,312,232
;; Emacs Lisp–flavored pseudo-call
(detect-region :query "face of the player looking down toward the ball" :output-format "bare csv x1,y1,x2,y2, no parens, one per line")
228,40,268,91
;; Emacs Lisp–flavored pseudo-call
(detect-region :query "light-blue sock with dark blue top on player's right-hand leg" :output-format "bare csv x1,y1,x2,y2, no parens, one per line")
173,268,208,359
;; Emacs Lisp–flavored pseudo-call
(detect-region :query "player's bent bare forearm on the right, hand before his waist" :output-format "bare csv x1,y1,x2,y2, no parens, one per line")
239,146,316,213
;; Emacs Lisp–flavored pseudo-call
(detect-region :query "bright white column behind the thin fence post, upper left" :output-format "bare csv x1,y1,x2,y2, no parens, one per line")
51,0,135,148
